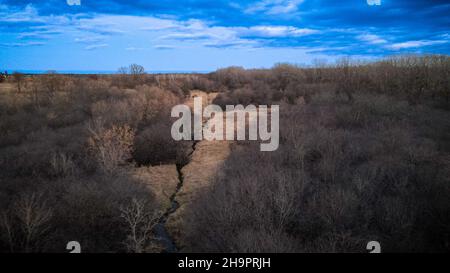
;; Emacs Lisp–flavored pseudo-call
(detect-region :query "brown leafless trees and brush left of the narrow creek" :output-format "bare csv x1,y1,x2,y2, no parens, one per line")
0,66,182,252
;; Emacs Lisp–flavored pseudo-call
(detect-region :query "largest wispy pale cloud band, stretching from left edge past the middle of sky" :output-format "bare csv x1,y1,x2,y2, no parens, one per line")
0,3,320,50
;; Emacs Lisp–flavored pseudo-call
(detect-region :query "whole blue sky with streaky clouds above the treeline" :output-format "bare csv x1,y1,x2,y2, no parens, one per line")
0,0,450,71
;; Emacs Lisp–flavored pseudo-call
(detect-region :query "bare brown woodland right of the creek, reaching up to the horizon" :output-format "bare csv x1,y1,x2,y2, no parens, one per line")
185,54,450,252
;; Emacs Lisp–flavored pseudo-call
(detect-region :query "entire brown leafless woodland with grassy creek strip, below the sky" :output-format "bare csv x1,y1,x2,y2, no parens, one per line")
0,55,450,252
